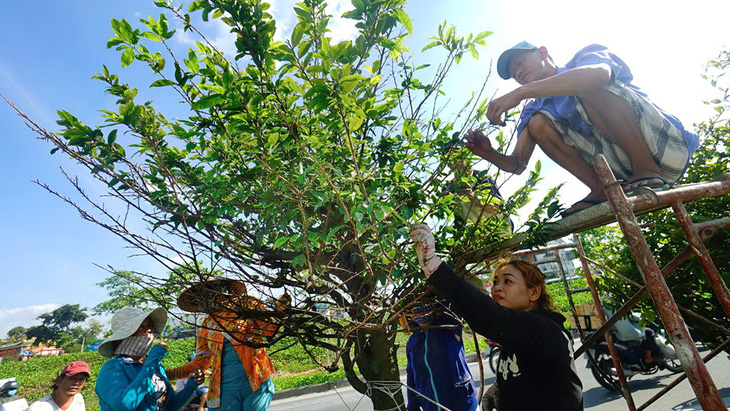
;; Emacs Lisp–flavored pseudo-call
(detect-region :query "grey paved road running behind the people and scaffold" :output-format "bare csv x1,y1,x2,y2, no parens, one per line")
270,346,730,411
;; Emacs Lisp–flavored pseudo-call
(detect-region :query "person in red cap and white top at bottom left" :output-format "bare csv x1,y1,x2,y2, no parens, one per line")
28,361,91,411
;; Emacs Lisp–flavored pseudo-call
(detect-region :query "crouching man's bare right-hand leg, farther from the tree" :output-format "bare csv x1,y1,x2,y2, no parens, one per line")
578,89,668,189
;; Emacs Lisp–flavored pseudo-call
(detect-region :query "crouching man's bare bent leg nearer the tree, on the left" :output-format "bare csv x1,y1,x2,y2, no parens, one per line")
527,112,606,214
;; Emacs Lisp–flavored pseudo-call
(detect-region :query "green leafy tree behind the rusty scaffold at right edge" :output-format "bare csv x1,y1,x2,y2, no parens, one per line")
581,51,730,346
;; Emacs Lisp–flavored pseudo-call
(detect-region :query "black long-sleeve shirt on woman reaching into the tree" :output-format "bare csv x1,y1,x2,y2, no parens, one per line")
428,263,583,411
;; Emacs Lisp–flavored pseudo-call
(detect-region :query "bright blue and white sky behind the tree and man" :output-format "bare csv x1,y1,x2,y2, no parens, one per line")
0,0,730,337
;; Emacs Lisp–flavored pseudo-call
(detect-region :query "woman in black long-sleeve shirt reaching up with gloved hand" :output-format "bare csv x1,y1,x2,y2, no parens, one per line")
410,225,583,411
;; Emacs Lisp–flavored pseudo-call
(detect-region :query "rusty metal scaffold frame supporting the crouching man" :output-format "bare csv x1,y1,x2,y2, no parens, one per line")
484,155,730,411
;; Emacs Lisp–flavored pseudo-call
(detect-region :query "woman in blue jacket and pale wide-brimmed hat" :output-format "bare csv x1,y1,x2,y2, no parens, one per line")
95,307,204,411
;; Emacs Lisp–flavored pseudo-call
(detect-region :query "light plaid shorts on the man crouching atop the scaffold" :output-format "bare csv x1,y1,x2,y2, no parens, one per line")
539,81,690,182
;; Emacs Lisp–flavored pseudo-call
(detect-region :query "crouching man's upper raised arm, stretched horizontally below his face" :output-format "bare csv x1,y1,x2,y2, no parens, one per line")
487,63,611,124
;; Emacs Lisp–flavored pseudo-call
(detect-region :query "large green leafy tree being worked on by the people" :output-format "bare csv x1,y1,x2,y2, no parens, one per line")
8,0,558,409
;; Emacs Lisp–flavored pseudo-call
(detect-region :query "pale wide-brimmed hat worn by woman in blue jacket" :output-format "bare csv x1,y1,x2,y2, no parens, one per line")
97,307,167,357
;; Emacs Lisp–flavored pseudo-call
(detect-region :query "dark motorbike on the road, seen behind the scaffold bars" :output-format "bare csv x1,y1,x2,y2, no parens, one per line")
586,326,683,391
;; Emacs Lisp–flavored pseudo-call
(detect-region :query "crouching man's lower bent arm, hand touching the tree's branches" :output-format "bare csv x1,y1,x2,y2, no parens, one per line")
464,128,536,174
